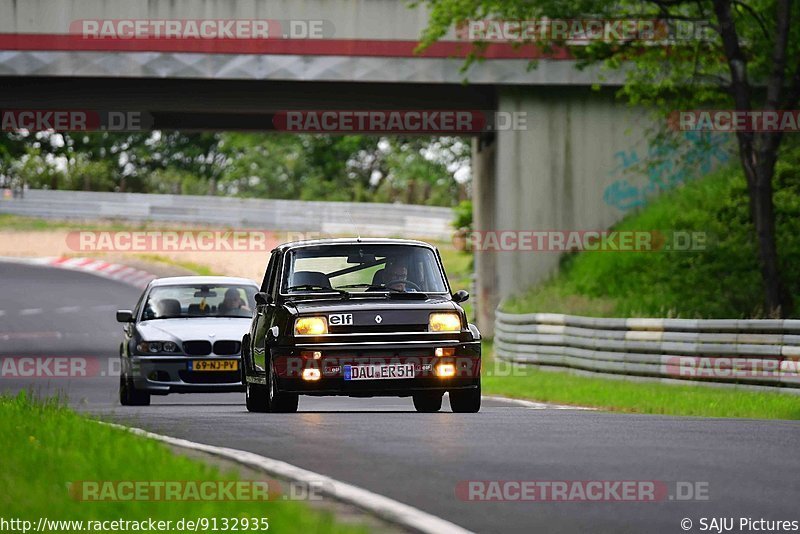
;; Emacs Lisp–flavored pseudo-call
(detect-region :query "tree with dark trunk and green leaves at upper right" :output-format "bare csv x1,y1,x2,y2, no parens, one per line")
421,0,800,317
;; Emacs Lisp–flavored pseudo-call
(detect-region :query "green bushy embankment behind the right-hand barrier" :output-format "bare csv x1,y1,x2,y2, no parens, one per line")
503,144,800,318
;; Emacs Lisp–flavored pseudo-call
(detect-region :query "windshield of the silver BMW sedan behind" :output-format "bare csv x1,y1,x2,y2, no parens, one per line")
142,284,256,321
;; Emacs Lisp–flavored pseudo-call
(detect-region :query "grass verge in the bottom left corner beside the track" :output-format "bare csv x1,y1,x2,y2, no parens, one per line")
0,392,366,533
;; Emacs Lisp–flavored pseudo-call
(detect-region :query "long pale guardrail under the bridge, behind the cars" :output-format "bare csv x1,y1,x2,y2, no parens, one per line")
0,189,453,240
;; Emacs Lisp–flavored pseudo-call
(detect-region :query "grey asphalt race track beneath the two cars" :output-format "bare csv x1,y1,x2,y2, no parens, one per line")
0,263,800,533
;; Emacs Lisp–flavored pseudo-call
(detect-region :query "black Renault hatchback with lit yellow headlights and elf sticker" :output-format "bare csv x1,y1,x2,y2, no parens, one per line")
242,239,481,412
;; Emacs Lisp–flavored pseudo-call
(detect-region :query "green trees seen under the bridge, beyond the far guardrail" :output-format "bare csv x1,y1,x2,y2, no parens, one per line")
0,131,470,206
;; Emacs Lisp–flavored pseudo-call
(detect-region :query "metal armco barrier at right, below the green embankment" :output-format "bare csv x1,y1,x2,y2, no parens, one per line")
494,311,800,393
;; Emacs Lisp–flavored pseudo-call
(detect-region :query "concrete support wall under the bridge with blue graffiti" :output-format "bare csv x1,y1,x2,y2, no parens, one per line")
477,87,649,322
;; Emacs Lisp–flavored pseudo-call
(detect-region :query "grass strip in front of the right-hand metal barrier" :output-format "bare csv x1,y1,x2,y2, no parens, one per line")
481,341,800,419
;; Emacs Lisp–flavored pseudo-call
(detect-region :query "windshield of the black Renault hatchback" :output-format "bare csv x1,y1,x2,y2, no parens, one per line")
281,244,447,294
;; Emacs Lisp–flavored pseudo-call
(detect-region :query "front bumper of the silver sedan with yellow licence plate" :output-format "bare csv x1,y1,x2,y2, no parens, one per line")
123,356,244,395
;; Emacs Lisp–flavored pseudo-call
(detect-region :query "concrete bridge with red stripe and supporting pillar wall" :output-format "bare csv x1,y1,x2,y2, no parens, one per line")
0,0,724,334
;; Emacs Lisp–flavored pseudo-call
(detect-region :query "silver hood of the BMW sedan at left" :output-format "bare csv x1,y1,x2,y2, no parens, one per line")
136,317,251,343
